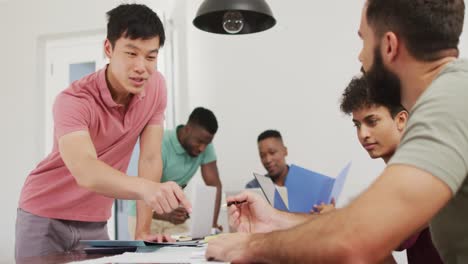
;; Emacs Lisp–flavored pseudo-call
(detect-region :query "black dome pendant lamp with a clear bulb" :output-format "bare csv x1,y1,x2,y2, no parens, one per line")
193,0,276,35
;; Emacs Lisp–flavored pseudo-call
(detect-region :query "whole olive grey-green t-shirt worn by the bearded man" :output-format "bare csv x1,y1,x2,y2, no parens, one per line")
389,60,468,264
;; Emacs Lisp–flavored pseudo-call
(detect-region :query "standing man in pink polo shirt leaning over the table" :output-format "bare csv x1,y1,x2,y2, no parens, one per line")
15,4,191,258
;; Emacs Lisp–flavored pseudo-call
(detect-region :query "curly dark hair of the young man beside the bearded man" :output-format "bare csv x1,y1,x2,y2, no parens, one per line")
340,76,405,118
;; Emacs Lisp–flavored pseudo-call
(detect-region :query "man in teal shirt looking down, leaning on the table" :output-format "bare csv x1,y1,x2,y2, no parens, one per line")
129,107,221,234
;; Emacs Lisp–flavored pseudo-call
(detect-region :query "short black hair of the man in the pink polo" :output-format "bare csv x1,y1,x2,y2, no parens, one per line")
107,4,166,47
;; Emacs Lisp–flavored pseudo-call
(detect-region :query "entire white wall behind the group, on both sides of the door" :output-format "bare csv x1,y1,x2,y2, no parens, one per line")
0,0,468,262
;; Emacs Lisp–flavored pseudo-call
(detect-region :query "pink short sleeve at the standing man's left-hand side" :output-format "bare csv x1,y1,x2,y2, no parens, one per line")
53,93,91,138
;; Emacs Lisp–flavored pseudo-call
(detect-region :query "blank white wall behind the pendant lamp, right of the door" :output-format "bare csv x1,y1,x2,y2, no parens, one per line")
187,0,382,201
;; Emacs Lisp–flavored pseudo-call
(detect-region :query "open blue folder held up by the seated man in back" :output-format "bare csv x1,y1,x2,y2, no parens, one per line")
284,162,351,213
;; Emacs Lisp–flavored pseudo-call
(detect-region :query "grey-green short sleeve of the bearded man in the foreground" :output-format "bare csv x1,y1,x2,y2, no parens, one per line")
389,60,468,195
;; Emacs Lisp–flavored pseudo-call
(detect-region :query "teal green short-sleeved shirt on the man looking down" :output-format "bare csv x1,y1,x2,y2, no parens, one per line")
129,125,216,215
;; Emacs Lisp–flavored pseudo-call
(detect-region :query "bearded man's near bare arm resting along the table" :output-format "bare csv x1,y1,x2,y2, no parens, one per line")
206,165,452,263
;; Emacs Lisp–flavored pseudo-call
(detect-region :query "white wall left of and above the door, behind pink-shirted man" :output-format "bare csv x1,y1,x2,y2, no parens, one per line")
0,0,170,263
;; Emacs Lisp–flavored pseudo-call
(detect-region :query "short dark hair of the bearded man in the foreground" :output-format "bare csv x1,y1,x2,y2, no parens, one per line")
365,0,465,61
